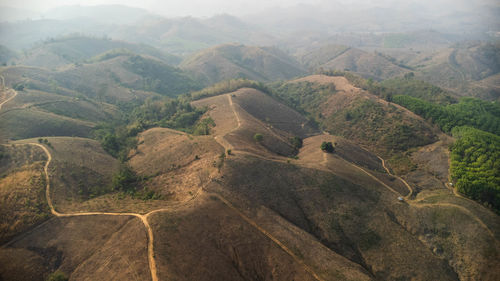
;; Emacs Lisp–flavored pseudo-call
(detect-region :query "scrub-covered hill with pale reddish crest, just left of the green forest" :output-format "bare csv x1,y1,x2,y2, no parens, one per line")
275,75,436,153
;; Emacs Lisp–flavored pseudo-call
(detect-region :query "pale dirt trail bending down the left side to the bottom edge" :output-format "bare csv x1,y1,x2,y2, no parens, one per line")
28,143,158,281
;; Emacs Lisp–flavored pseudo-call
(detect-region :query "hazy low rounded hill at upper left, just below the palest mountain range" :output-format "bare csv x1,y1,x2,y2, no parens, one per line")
16,36,180,69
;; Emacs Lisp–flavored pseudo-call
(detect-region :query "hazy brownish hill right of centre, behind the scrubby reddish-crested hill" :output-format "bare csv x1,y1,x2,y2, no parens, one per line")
299,45,410,80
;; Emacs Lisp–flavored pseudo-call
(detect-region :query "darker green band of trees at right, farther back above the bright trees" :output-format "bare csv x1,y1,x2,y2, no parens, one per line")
393,95,500,135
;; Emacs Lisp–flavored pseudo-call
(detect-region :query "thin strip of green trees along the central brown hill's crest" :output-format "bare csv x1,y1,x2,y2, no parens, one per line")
191,79,269,100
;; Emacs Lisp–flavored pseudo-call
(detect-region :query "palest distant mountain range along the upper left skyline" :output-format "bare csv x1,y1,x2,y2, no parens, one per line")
0,12,274,56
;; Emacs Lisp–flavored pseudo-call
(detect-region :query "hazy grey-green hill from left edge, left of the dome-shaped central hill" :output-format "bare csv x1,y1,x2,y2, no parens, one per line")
0,53,200,103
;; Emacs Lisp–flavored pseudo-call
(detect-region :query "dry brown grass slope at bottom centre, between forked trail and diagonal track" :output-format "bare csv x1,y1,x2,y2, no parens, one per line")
151,191,332,280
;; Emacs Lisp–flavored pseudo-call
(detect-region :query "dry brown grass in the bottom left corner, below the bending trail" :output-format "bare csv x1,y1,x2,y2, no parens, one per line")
0,213,151,281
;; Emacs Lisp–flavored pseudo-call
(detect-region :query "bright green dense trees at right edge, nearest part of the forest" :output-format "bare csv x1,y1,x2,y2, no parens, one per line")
451,126,500,213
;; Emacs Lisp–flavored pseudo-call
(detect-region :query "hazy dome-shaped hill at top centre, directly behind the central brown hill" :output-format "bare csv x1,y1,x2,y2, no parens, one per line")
180,44,305,85
